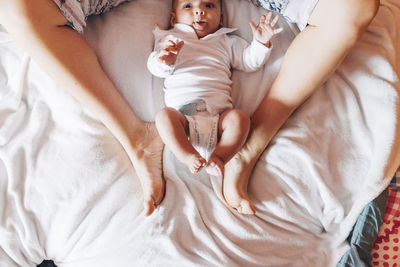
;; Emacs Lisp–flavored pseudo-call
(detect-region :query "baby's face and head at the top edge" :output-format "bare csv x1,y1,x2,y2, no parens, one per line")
171,0,221,38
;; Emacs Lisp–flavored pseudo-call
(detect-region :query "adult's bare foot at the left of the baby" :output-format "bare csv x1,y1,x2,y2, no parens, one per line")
131,123,165,216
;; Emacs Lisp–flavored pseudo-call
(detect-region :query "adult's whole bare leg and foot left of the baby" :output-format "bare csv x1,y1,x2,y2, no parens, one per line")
0,0,164,215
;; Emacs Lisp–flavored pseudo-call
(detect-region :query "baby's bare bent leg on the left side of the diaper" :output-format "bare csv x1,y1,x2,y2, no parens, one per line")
156,108,207,173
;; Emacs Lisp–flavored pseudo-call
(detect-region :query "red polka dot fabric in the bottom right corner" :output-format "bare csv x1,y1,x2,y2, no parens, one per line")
371,189,400,267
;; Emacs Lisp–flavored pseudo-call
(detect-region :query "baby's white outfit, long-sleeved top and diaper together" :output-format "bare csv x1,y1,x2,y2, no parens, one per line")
147,24,271,160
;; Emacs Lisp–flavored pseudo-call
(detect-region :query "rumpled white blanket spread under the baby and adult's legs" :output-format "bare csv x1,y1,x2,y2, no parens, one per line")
0,0,400,267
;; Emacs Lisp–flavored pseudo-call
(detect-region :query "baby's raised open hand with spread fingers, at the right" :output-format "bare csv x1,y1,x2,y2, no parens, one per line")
250,12,283,47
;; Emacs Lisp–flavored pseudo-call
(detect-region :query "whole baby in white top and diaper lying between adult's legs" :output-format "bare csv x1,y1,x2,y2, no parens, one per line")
147,0,282,214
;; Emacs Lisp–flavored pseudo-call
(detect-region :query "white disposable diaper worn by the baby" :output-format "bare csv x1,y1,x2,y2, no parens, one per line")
179,100,219,161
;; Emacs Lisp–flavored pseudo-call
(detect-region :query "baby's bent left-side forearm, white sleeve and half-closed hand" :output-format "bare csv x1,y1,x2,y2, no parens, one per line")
147,40,184,78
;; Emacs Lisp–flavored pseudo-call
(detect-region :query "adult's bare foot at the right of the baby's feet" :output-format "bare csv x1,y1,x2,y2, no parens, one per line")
223,152,256,215
